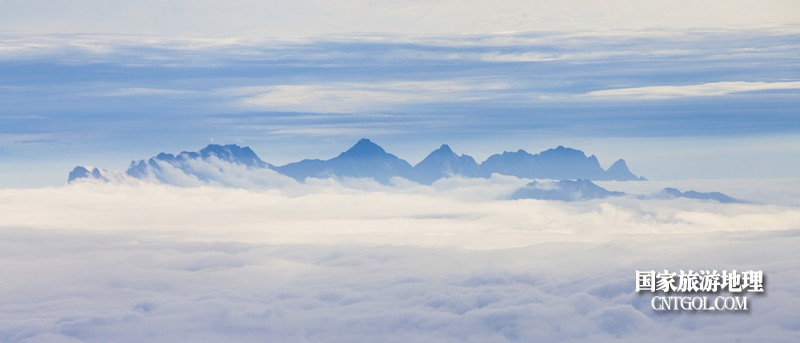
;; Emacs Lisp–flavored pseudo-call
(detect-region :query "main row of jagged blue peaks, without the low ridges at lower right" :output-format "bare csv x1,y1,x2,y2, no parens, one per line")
68,139,645,184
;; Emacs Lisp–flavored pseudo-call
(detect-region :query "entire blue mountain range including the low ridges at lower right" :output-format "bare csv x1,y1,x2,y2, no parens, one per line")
68,139,741,203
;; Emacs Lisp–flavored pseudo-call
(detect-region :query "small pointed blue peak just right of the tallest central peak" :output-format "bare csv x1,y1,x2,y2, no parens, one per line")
414,144,486,184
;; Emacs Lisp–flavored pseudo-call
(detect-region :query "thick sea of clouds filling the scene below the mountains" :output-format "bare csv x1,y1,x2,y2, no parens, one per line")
0,176,800,342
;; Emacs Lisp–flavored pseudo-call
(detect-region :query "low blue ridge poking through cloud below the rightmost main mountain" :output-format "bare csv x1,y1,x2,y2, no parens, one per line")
511,179,625,201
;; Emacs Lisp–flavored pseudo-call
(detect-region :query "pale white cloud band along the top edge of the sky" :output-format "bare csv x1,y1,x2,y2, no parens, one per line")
0,0,800,37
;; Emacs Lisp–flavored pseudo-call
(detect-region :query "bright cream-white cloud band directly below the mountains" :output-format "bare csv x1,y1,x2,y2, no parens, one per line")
0,179,800,249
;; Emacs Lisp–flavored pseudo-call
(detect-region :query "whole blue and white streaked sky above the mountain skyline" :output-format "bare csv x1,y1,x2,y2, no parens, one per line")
0,0,800,187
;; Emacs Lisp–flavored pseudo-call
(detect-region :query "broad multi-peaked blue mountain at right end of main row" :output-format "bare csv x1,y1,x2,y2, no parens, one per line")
481,146,643,181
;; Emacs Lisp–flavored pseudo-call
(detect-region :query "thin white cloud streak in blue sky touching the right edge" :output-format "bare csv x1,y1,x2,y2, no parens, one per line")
587,81,800,99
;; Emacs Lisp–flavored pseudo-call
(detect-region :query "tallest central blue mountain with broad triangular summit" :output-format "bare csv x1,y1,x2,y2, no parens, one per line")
275,139,414,183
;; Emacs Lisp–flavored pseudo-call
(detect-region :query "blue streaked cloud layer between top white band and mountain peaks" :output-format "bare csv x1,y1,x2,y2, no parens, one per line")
0,28,800,186
